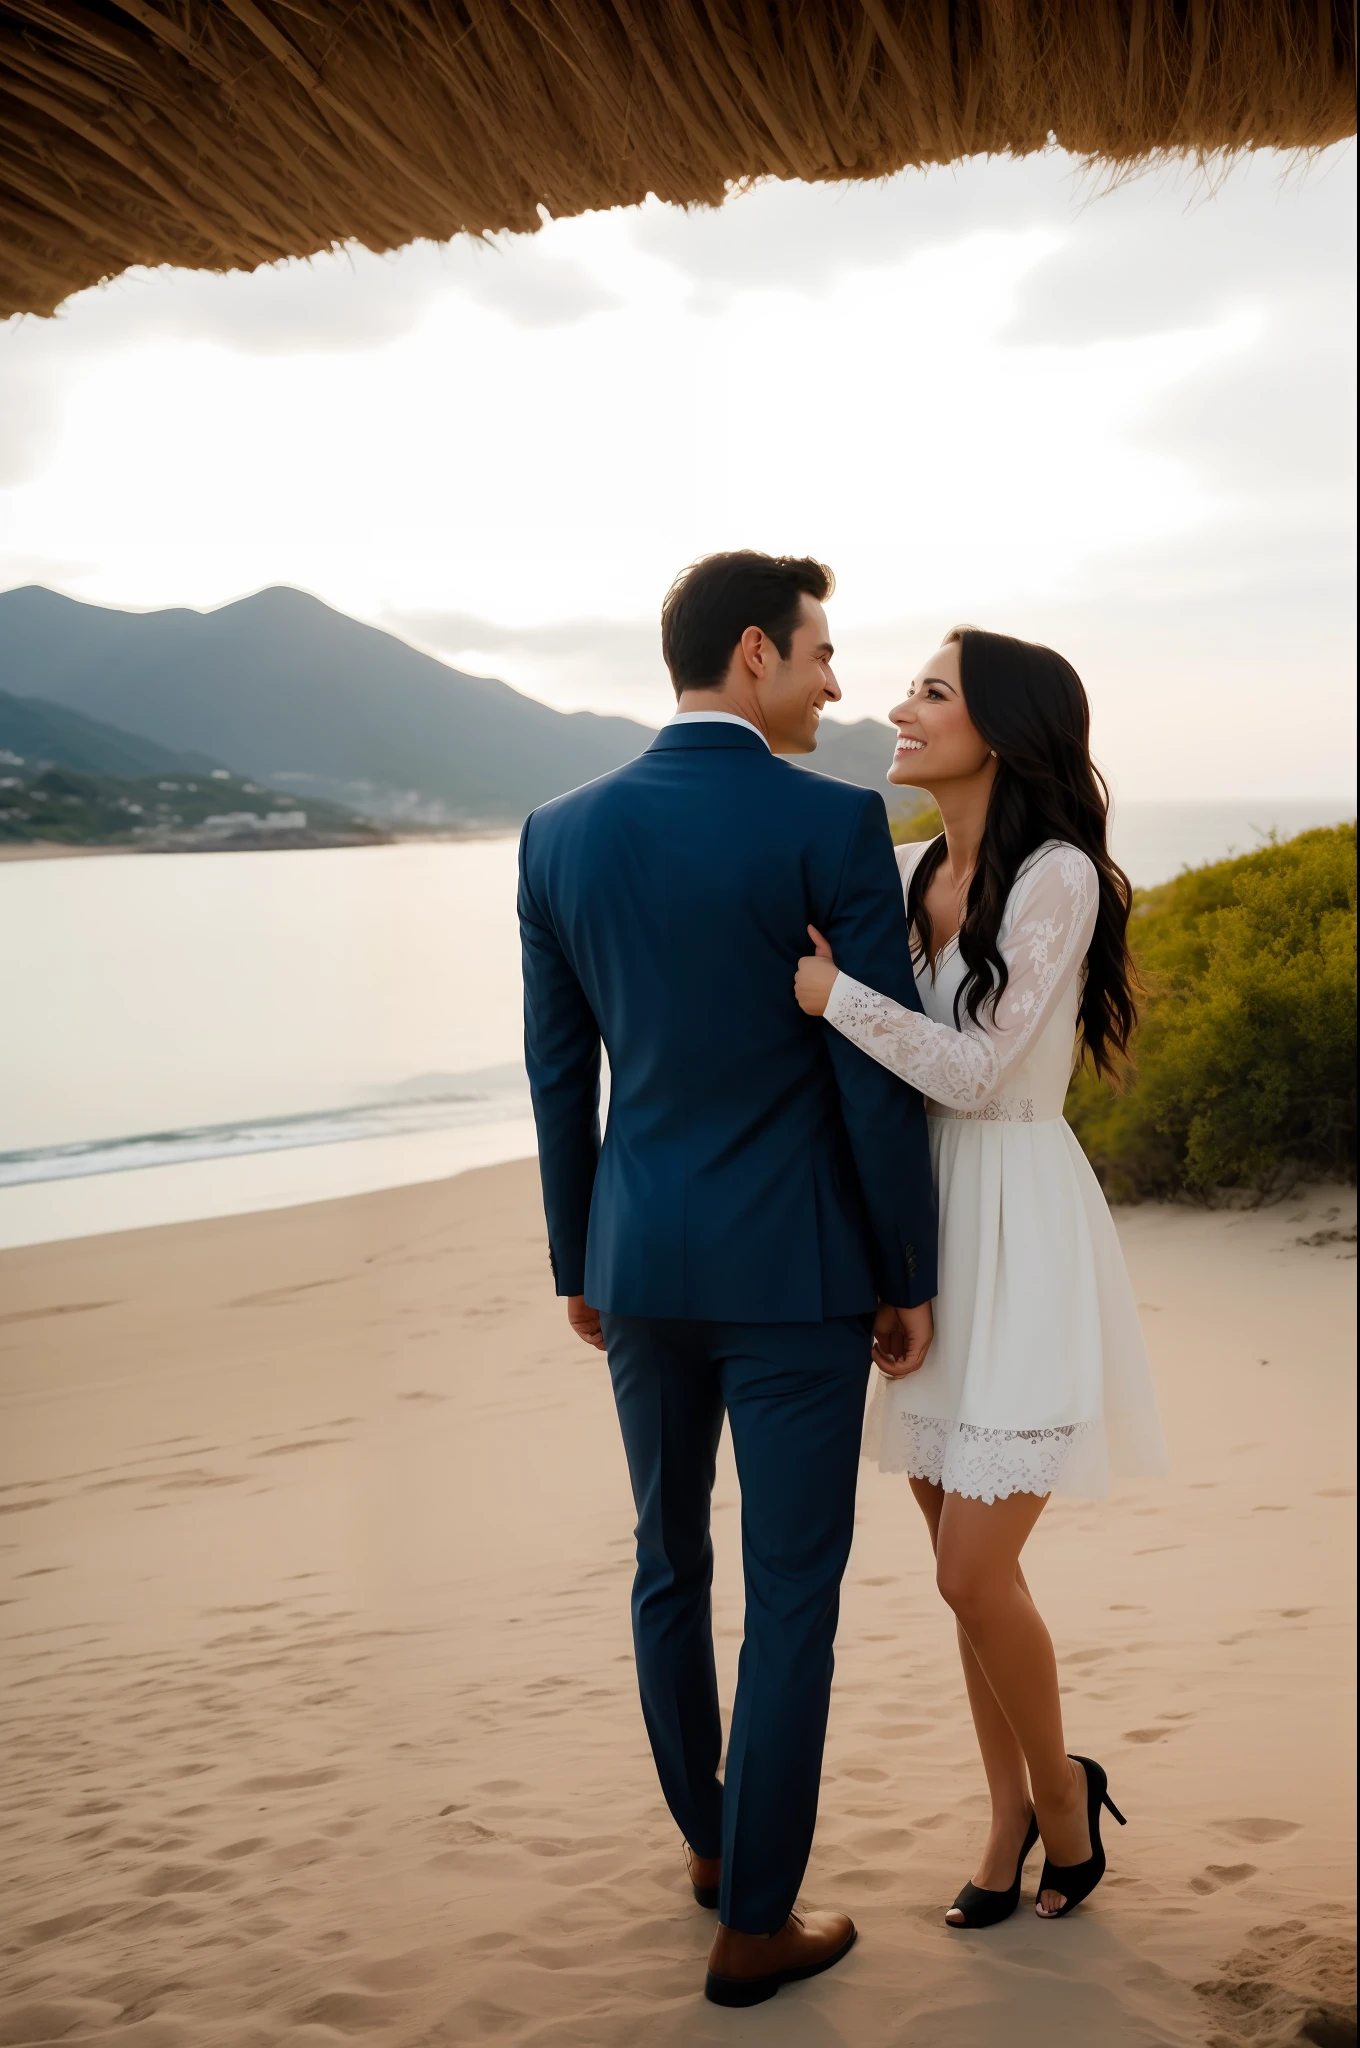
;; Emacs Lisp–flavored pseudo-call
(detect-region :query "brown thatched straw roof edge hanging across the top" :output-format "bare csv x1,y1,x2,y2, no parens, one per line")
0,0,1356,313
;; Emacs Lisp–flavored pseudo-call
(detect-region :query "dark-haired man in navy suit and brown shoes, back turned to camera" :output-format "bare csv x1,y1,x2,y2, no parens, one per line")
520,553,936,2005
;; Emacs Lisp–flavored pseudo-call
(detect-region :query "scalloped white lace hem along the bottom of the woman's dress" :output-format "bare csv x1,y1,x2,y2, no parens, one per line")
864,1393,1108,1501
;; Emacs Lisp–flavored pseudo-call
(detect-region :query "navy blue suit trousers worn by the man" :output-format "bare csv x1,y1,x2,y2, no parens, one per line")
600,1315,873,1933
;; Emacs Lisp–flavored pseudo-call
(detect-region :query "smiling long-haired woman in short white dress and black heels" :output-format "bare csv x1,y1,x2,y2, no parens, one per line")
797,627,1165,1927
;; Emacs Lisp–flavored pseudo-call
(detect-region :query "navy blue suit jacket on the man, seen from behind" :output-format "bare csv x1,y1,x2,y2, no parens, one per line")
520,721,936,1323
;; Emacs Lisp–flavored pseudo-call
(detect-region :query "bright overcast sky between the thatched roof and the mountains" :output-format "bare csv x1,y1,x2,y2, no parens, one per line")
0,145,1356,799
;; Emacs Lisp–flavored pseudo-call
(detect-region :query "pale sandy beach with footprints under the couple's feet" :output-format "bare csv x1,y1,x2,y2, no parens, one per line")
0,1163,1356,2048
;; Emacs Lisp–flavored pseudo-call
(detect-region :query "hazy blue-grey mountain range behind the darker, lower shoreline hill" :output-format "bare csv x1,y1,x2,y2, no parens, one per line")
0,584,913,825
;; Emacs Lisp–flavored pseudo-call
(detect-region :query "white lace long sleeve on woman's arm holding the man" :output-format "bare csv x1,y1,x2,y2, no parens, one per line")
825,846,1100,1110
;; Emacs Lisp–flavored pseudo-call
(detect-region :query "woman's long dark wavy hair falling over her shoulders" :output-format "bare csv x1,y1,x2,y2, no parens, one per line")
907,627,1137,1075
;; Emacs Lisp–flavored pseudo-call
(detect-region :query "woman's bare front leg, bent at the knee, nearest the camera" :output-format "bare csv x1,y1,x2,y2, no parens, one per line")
936,1493,1092,1913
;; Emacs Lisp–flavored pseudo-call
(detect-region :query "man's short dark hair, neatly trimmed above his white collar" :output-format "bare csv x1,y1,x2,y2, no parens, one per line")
662,549,836,696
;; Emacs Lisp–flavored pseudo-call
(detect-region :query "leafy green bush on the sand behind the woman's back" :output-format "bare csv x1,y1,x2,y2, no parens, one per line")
1067,823,1356,1200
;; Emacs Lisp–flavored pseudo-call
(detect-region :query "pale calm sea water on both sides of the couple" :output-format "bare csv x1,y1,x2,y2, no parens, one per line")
0,801,1354,1247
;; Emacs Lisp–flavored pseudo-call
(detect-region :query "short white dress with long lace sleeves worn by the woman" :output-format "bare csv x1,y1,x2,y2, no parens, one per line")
825,842,1165,1501
